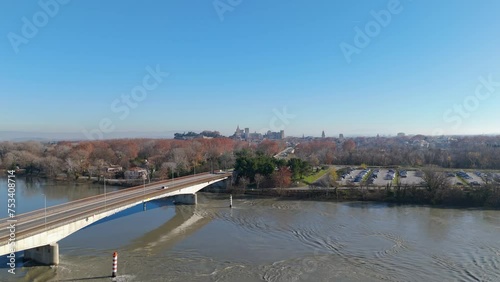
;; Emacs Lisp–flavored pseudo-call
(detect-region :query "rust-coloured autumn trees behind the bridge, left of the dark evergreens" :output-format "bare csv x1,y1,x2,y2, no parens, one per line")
0,138,285,179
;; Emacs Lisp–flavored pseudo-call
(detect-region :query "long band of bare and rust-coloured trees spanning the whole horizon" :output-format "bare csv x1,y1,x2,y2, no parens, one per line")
0,134,500,185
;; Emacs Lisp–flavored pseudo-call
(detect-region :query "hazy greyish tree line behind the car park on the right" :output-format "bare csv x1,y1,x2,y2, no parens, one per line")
295,135,500,169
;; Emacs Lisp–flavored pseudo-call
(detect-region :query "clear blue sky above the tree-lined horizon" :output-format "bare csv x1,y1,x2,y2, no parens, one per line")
0,0,500,137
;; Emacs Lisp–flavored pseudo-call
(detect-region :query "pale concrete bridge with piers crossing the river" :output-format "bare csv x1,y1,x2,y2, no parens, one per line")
0,173,231,265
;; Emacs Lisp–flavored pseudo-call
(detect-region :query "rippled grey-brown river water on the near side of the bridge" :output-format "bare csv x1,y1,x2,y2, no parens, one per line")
0,180,500,282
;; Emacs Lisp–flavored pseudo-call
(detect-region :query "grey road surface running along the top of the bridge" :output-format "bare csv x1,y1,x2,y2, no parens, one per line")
0,173,229,248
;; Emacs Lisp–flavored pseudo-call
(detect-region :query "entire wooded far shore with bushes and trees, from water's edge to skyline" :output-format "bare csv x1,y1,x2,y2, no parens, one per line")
0,138,500,208
